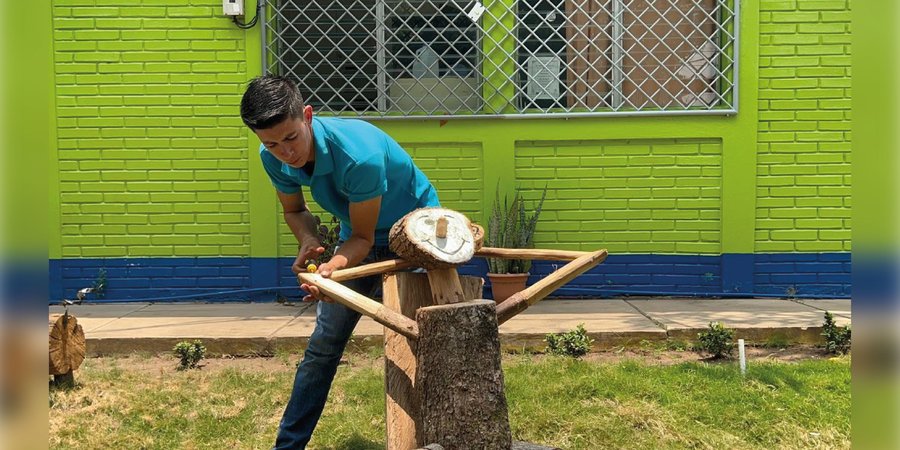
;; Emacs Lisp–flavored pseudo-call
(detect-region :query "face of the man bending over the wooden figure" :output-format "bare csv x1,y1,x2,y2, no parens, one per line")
254,105,316,168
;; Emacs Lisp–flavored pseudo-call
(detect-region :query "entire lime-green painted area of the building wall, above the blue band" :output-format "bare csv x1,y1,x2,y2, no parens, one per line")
51,0,851,258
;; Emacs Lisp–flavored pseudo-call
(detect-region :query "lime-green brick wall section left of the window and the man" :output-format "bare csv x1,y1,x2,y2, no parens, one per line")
53,0,250,258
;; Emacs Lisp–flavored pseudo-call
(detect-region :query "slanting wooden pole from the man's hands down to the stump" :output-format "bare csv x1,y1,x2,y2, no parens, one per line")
298,273,419,339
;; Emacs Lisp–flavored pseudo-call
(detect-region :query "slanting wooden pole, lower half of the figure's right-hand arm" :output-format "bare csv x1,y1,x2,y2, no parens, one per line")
497,249,607,324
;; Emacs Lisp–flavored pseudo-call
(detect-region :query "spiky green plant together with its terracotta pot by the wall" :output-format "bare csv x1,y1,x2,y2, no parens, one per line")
485,186,547,303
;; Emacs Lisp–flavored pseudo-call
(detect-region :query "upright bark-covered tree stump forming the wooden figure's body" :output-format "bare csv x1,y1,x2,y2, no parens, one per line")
416,300,512,450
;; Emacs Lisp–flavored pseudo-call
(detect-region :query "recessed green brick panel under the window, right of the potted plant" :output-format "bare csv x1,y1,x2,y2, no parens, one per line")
516,140,722,254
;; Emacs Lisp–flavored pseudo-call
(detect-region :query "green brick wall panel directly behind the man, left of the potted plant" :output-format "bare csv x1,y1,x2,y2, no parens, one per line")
278,142,484,257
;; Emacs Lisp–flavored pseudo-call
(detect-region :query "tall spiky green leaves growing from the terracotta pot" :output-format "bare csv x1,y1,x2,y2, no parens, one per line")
484,185,547,273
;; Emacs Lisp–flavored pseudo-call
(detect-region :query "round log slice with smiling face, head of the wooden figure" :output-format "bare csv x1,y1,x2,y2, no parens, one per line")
390,208,476,269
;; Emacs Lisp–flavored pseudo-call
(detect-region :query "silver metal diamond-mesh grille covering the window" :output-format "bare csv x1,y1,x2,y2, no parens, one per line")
261,0,740,117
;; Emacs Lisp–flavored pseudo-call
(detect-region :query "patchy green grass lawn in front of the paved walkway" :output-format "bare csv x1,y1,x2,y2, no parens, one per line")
49,350,850,449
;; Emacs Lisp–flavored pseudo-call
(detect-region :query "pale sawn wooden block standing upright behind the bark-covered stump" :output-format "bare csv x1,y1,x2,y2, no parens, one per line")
383,272,484,450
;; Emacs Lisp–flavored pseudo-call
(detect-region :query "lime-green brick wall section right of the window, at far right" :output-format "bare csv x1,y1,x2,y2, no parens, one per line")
756,0,851,252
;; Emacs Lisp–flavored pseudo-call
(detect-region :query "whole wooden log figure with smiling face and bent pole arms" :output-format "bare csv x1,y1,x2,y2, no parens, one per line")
298,208,607,450
